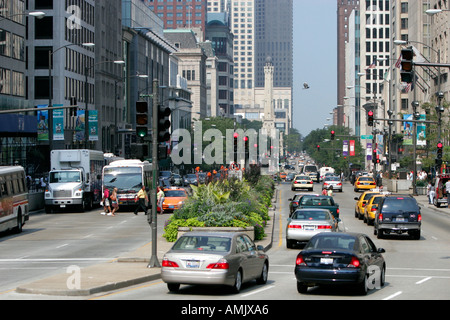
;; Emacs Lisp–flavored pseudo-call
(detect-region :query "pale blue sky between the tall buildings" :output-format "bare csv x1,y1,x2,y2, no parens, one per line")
293,0,337,137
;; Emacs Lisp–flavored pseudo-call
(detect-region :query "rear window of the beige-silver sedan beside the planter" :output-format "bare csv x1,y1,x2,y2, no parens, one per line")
172,235,231,252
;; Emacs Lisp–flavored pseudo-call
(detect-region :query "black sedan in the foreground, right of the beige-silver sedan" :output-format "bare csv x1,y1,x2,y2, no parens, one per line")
295,232,386,295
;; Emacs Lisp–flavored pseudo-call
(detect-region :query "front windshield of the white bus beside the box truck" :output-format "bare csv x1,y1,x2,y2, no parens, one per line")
103,168,142,192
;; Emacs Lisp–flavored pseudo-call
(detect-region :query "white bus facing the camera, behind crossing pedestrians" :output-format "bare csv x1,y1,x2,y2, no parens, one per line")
102,160,152,206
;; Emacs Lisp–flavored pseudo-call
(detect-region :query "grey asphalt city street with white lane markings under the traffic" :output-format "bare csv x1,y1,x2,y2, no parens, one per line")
0,183,450,301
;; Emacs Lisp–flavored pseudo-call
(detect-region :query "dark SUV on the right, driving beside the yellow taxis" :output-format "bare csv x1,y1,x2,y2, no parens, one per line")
373,195,422,240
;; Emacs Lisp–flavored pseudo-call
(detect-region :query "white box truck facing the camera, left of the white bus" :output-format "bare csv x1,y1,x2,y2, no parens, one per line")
45,149,104,213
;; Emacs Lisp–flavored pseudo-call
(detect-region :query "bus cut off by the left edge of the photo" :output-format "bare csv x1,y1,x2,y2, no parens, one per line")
0,166,29,233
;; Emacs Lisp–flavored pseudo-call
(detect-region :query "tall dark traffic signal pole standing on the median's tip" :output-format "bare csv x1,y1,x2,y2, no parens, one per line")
147,79,162,268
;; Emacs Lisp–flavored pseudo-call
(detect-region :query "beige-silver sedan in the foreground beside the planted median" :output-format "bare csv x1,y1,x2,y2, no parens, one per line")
161,232,269,292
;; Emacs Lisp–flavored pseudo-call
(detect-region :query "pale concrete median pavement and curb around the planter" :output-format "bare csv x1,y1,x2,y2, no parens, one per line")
16,206,275,296
